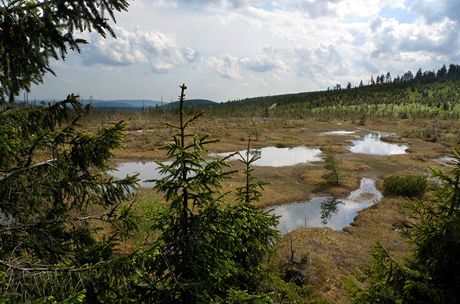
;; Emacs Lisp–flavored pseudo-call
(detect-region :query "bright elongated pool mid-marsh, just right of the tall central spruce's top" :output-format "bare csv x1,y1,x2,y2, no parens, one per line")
211,147,322,167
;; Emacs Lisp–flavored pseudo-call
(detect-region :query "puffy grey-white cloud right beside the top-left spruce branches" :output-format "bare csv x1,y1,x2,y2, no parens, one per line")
83,27,198,73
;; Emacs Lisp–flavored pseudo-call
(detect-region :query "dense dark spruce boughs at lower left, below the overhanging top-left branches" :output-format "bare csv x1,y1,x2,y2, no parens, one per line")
0,95,136,301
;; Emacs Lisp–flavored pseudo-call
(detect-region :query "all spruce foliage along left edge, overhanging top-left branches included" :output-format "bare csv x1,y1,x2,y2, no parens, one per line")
0,0,136,303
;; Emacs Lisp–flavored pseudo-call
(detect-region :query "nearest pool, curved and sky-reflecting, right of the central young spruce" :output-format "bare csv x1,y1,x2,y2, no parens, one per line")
270,178,383,234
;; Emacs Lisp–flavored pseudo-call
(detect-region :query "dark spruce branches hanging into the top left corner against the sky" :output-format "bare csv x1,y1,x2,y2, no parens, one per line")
0,0,128,104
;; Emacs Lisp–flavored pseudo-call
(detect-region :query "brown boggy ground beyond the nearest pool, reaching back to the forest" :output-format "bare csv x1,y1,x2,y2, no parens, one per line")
98,113,452,206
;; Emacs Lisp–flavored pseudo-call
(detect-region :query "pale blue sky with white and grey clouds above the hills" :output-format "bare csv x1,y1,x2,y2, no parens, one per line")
29,0,460,102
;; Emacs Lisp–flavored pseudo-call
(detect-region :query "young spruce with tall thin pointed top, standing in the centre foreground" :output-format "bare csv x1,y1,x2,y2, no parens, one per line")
139,85,278,303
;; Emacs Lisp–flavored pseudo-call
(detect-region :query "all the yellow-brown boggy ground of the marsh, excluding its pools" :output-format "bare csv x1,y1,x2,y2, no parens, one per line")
90,113,460,303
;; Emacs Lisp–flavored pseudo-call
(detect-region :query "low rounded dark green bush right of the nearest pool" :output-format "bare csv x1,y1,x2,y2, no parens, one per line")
383,175,427,197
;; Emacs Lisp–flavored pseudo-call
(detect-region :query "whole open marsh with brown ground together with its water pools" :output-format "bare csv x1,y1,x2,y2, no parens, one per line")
101,113,456,303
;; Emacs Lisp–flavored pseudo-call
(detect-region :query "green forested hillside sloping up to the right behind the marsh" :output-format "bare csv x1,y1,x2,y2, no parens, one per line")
209,70,460,119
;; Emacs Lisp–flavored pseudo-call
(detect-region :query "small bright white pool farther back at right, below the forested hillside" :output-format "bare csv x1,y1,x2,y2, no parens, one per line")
348,133,408,155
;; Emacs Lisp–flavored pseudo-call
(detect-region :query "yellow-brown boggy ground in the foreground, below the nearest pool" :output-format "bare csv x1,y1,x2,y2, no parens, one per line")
276,198,411,303
